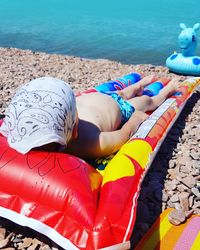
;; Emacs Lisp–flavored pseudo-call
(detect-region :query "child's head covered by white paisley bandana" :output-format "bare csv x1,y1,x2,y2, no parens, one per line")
0,77,76,154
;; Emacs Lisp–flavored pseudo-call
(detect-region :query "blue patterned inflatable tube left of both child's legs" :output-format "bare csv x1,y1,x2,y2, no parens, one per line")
95,73,141,92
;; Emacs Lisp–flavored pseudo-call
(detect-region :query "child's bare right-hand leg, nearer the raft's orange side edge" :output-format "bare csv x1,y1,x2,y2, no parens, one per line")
128,80,179,112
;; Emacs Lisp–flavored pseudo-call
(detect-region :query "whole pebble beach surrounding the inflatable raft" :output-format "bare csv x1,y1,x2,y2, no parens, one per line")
0,48,200,250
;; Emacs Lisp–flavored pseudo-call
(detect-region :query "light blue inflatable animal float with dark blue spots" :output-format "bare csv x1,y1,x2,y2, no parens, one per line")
166,23,200,75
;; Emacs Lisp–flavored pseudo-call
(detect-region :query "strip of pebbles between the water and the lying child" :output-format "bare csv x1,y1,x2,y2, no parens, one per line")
0,47,186,113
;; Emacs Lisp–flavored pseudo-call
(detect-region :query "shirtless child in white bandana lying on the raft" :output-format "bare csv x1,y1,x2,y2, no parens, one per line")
0,76,178,158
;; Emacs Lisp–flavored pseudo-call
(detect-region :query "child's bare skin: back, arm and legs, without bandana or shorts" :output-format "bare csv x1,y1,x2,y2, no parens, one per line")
67,77,177,158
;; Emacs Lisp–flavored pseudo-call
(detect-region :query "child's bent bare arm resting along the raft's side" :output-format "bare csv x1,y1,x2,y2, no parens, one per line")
96,111,148,157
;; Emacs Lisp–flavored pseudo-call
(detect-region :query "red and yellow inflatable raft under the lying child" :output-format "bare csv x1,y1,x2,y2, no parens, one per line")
0,73,200,250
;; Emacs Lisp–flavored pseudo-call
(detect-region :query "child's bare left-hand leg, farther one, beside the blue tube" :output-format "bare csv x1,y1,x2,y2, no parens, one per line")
116,75,156,100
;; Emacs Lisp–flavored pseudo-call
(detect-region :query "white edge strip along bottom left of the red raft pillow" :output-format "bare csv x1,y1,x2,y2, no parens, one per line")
0,206,79,250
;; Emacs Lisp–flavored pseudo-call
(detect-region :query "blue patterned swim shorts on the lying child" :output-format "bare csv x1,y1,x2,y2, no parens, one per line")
102,92,135,124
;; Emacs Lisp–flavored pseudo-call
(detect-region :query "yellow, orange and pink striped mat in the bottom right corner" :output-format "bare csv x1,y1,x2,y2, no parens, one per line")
135,209,200,250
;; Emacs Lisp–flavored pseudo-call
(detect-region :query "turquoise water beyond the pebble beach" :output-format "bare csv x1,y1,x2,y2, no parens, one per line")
0,0,200,65
